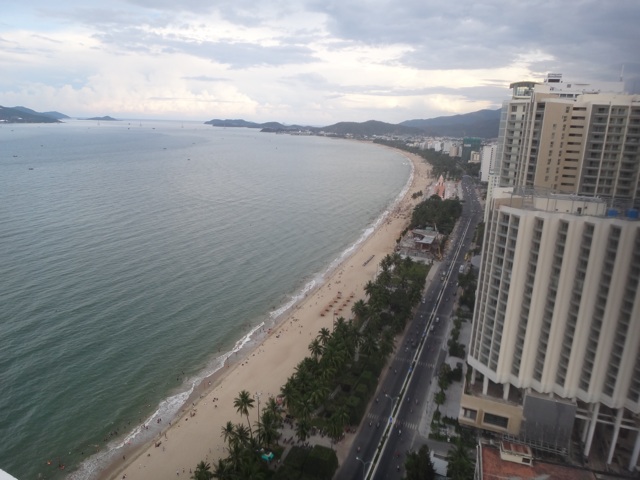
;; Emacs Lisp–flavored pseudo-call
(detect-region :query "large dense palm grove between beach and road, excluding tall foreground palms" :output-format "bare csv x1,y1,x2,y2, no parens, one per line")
281,254,427,441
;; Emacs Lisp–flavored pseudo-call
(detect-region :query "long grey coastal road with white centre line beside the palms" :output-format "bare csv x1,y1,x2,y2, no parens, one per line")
335,177,482,480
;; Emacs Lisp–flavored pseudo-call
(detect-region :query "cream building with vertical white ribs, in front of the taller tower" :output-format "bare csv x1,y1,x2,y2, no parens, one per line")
459,187,640,469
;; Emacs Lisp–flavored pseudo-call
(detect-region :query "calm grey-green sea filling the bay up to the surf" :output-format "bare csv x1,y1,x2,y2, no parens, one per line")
0,120,411,480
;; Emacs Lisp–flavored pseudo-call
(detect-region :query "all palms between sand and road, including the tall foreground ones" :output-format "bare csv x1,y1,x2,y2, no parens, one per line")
192,254,428,480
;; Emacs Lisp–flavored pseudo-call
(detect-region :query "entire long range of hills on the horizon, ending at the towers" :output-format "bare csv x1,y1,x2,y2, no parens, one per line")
204,109,500,138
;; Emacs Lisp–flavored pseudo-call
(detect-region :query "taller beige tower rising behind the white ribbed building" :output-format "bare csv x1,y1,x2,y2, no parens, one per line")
496,75,640,208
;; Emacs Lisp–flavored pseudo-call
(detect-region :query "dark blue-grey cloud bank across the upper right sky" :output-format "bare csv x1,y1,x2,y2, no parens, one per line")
309,0,640,79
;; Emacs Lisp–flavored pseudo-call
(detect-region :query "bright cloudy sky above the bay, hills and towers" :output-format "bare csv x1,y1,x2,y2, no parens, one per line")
0,0,640,125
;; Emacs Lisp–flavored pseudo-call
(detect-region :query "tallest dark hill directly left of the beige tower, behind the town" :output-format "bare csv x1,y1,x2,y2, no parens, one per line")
400,109,500,138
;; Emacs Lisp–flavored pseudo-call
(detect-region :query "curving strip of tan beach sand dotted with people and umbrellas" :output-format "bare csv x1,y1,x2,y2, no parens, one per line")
99,152,430,480
